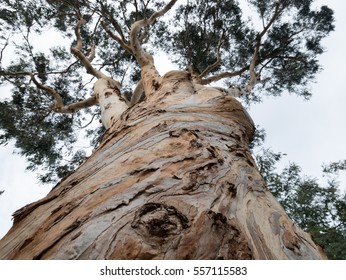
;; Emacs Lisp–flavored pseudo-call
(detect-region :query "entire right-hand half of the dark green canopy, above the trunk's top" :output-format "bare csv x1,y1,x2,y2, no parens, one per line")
156,0,334,99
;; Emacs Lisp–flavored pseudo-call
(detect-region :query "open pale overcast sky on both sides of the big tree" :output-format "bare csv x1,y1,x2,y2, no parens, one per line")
0,0,346,238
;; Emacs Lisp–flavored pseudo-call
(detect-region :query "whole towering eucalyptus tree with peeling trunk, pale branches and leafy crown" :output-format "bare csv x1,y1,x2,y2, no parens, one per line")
0,0,334,259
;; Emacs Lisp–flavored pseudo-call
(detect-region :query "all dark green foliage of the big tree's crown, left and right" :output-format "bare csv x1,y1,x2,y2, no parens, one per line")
0,0,334,182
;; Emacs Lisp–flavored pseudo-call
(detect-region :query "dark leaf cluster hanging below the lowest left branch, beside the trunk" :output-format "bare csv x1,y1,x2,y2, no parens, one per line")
0,87,83,183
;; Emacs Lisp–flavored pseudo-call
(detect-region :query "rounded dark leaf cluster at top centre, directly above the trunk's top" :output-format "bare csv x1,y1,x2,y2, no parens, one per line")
159,0,251,73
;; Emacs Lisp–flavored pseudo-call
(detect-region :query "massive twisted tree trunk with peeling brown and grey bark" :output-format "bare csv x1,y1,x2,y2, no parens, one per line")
0,72,325,259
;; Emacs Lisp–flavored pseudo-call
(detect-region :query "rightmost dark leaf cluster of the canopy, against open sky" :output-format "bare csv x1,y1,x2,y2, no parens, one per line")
255,1,334,98
